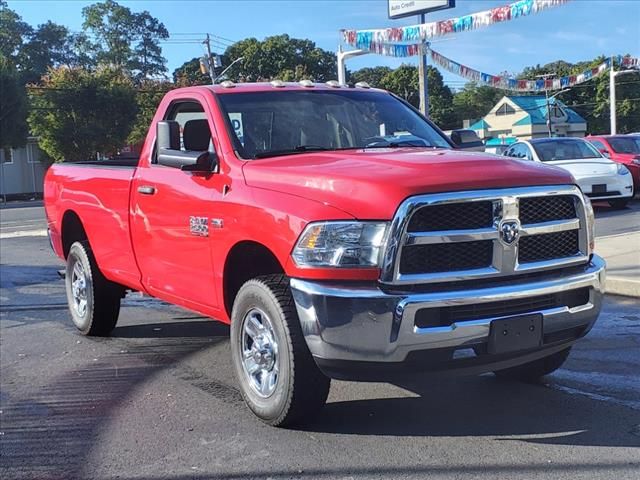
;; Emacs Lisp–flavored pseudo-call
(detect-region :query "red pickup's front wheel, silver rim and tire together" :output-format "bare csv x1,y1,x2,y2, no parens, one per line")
231,275,330,426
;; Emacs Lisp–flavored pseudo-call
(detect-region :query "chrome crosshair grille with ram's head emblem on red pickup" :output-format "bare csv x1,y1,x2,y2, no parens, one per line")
381,186,589,284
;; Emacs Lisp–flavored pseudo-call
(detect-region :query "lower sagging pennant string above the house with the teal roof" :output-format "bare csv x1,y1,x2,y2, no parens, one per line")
429,50,624,92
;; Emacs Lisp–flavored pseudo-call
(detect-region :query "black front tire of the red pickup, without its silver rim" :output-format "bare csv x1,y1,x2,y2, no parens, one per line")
231,275,331,427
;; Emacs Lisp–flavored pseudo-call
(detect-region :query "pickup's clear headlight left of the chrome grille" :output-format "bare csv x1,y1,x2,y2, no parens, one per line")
291,222,387,267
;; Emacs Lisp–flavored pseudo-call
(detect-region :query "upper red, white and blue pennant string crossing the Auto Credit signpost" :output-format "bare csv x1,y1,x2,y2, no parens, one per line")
341,0,569,51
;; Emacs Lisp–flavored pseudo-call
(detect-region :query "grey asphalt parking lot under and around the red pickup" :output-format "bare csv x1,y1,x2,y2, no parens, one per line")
0,201,640,480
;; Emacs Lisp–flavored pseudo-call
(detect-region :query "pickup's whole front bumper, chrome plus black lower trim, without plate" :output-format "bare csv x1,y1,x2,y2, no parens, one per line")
291,255,605,380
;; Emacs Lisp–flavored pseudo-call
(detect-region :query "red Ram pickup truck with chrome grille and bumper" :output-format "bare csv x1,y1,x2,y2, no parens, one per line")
45,81,605,425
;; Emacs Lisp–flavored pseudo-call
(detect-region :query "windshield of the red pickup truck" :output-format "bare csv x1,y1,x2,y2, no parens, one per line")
218,90,451,159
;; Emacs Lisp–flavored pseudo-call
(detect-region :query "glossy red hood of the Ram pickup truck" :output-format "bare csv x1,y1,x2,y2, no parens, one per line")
244,148,575,220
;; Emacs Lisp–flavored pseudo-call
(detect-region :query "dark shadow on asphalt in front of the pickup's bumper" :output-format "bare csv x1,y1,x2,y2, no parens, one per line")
302,375,640,447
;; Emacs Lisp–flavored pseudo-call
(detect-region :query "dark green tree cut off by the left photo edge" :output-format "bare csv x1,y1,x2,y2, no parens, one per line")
0,56,27,148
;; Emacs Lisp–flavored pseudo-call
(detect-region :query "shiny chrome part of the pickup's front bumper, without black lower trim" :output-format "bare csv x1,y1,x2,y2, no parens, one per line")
291,255,605,372
